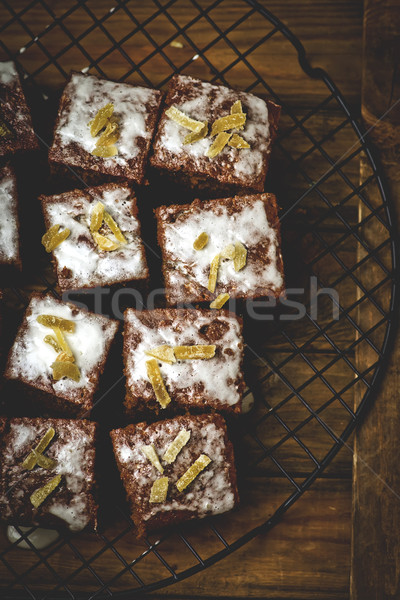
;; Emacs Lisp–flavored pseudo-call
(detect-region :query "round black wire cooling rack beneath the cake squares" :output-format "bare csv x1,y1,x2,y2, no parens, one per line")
0,0,398,599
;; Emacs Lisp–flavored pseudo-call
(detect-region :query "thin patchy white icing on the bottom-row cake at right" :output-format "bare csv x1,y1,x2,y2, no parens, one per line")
112,420,235,520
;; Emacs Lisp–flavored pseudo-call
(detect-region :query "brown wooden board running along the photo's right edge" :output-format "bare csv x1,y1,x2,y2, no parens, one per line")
351,0,400,600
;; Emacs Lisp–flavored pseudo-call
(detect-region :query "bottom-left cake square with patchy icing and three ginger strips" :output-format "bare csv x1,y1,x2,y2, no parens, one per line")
0,418,98,531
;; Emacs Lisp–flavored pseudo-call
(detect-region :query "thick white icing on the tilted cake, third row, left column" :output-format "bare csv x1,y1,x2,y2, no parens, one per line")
8,296,117,396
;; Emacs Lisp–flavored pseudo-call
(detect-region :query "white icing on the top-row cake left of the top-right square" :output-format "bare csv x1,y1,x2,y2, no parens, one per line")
56,73,158,166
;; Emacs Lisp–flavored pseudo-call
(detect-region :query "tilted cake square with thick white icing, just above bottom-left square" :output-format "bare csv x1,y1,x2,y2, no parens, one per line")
5,294,118,416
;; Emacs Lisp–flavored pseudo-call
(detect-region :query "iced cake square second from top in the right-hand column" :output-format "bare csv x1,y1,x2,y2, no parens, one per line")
156,194,284,305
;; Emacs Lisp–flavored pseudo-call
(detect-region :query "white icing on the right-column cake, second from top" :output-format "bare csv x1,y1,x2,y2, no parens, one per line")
161,199,283,294
